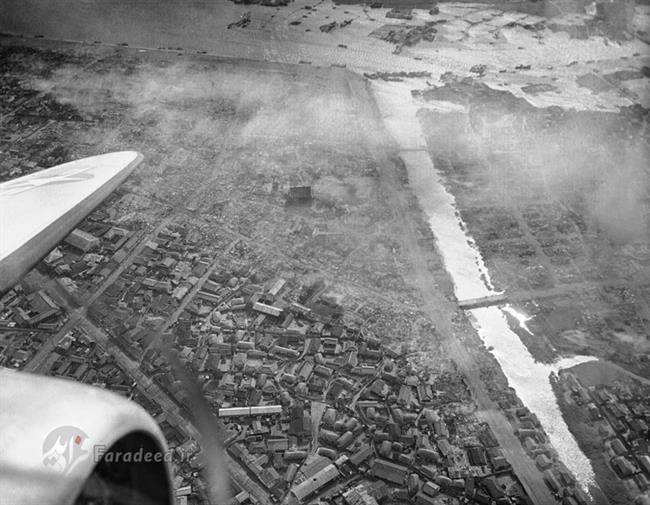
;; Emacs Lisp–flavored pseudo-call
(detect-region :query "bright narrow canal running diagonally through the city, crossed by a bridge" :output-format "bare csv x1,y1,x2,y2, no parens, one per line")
374,83,596,491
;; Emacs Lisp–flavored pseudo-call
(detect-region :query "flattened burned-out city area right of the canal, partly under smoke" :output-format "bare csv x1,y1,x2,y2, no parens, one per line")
417,78,650,377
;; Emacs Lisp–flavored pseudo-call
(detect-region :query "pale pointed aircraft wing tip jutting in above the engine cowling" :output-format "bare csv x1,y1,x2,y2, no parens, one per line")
0,151,142,293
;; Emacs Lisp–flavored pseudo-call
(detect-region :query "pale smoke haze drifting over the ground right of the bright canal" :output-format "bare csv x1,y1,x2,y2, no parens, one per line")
422,88,650,243
